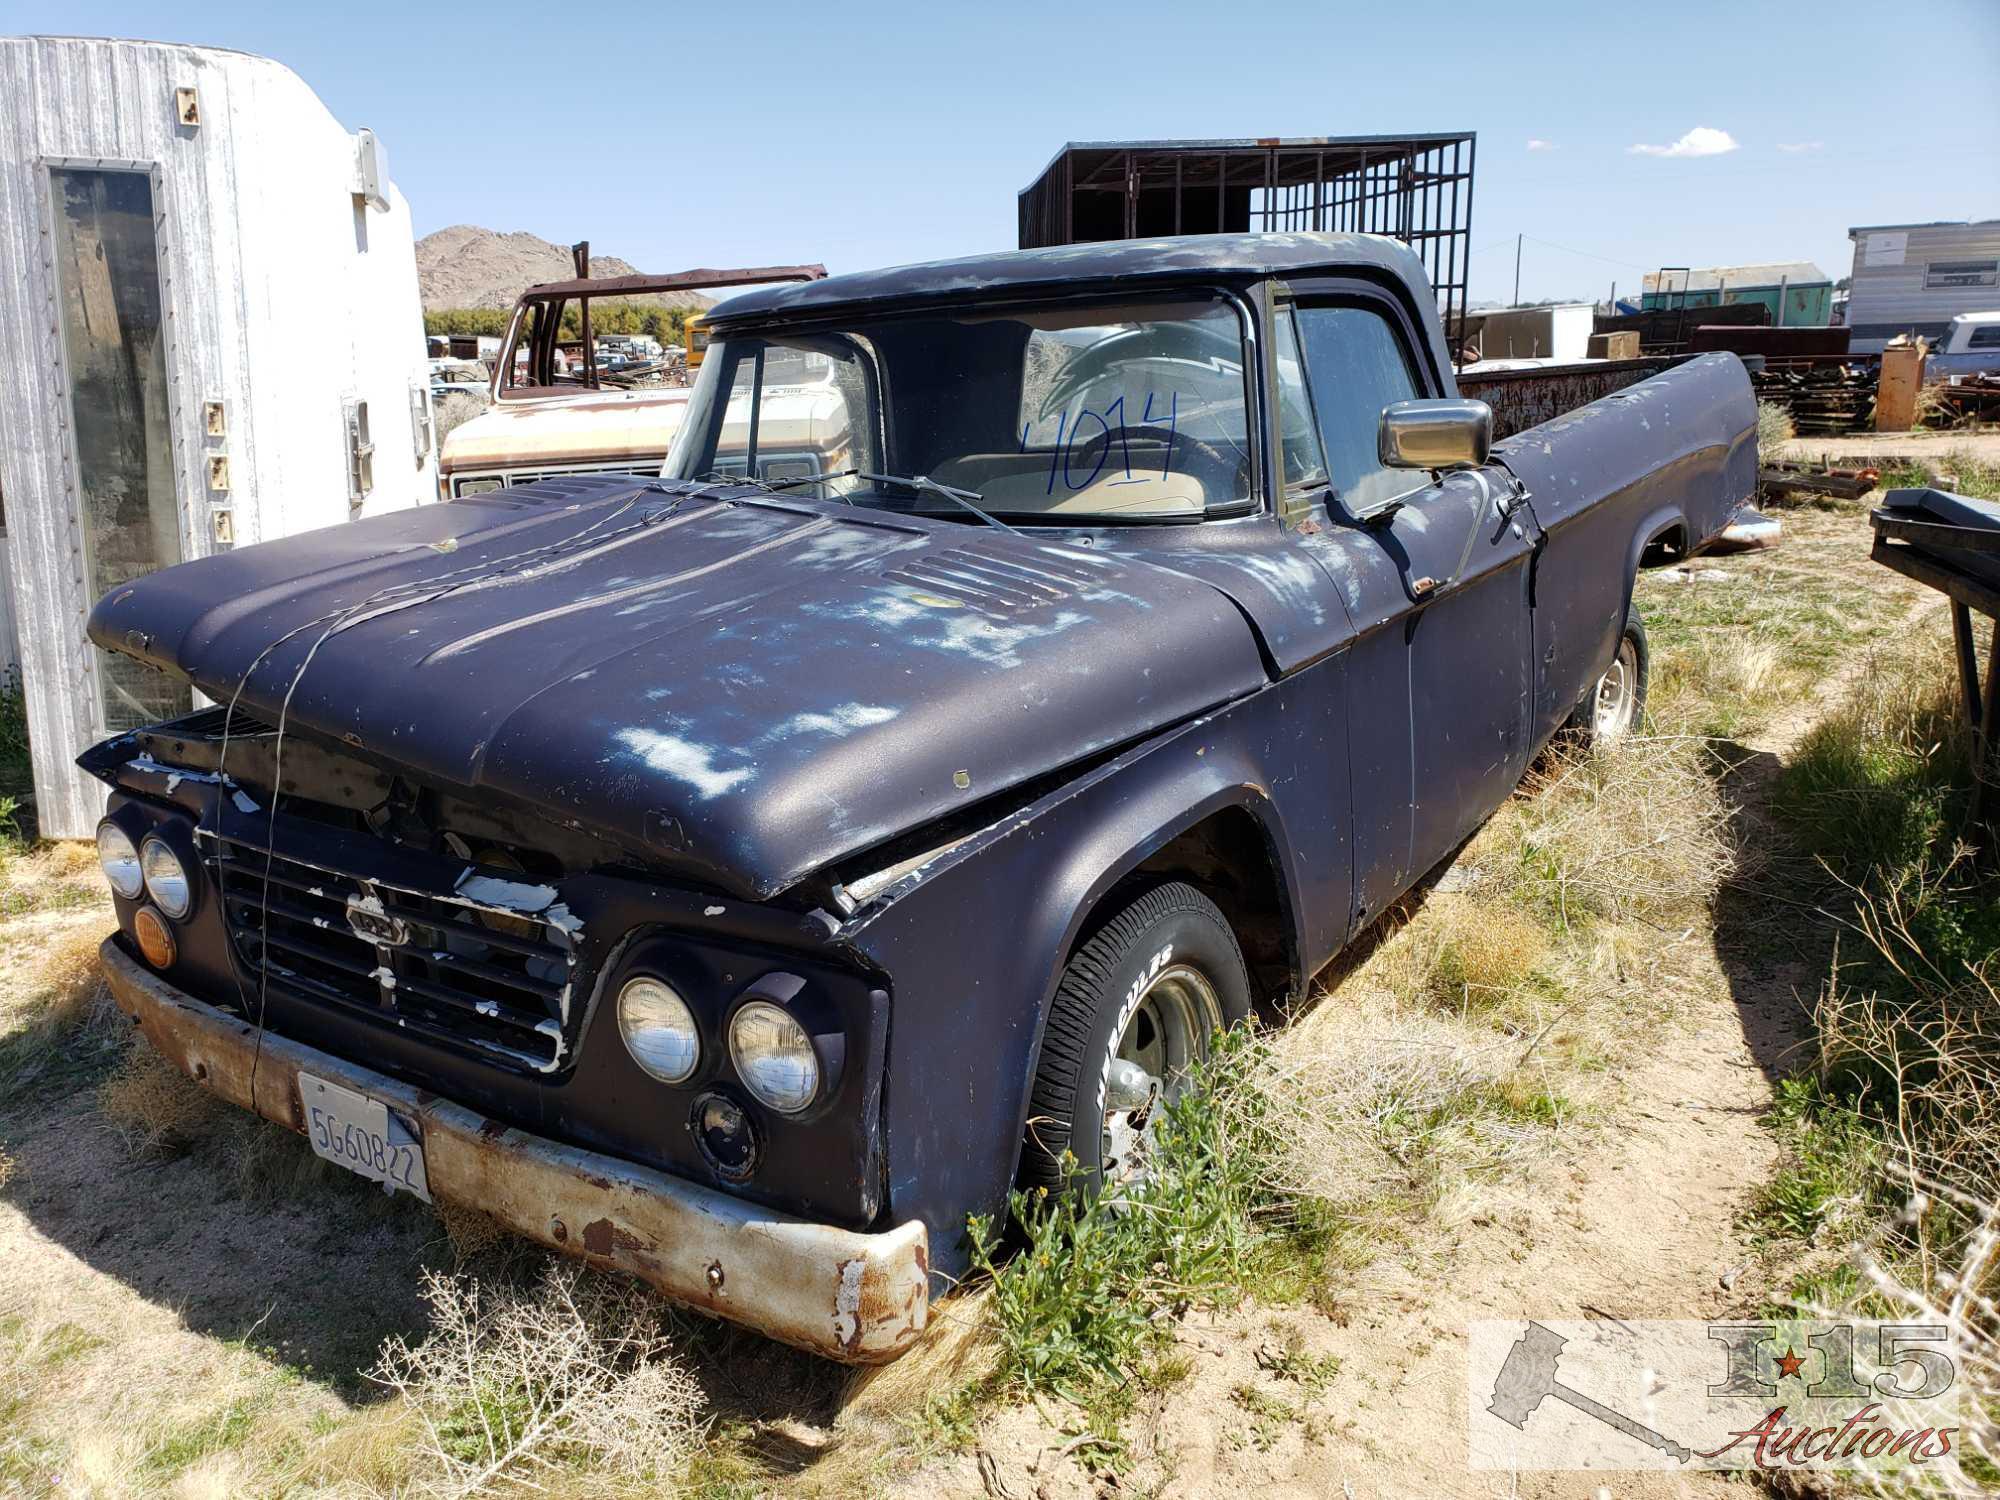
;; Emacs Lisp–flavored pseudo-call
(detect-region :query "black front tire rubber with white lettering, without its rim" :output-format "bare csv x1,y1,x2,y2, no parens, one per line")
1020,882,1250,1192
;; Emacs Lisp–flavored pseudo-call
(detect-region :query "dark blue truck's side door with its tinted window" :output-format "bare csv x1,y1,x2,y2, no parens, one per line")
1278,290,1534,922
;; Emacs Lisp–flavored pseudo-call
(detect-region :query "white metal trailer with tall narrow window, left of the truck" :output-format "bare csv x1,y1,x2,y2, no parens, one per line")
0,36,436,838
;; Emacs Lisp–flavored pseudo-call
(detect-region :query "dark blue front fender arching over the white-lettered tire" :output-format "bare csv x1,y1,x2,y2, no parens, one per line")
844,658,1352,1274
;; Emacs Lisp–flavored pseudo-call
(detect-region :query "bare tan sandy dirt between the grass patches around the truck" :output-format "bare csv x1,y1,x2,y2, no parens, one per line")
0,500,1938,1500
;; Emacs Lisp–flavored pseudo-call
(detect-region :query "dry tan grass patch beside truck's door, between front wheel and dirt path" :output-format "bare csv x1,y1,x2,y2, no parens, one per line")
1216,738,1736,1276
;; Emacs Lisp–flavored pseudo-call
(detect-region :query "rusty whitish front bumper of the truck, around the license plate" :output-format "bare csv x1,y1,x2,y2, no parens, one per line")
102,938,930,1364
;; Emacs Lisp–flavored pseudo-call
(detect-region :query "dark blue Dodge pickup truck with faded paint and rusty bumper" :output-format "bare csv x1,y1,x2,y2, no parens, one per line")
82,234,1756,1362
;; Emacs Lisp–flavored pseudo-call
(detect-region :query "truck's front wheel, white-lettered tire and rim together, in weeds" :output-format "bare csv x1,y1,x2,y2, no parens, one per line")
1020,882,1250,1192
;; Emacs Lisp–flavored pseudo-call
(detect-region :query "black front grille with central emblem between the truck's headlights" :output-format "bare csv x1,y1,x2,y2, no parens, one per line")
208,840,582,1074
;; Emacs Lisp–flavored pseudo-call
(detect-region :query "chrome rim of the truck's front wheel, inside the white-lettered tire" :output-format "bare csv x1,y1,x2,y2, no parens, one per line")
1098,964,1222,1188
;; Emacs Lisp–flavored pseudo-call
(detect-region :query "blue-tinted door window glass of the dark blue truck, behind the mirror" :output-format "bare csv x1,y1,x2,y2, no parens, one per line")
1296,304,1424,514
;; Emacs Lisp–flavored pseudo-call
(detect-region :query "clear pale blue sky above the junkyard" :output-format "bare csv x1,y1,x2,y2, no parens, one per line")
0,0,2000,300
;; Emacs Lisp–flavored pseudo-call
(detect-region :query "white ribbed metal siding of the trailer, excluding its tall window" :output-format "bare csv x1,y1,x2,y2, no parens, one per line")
0,38,436,836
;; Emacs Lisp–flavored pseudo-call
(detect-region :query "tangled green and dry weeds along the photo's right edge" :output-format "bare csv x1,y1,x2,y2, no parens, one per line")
1760,640,2000,1496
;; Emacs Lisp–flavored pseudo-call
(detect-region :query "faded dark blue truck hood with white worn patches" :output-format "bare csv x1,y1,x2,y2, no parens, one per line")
90,478,1266,898
